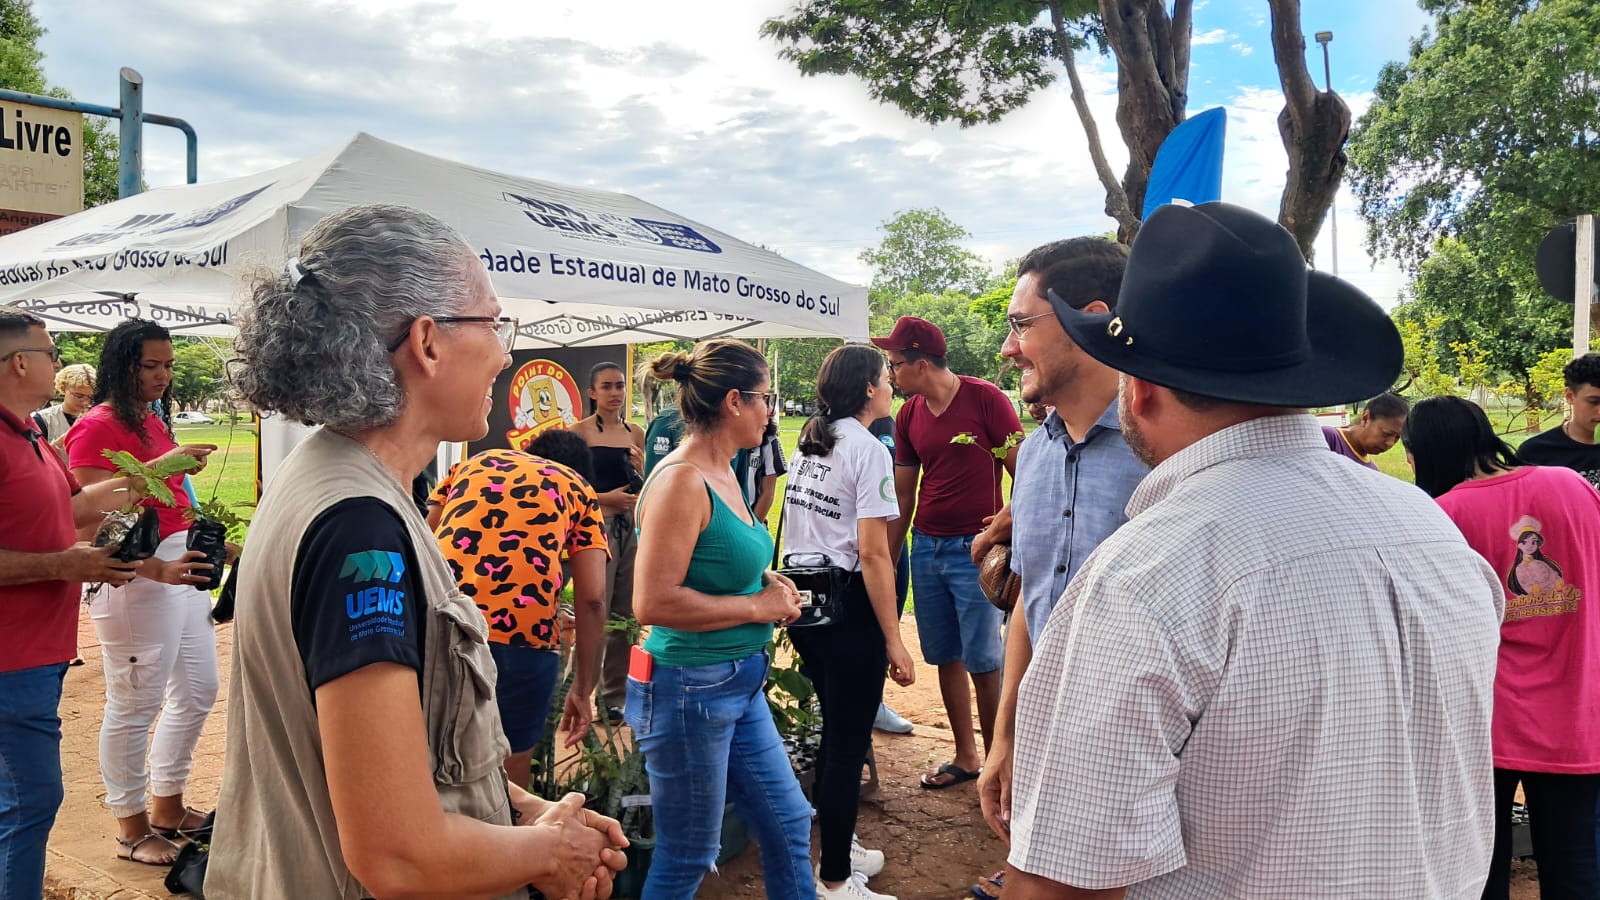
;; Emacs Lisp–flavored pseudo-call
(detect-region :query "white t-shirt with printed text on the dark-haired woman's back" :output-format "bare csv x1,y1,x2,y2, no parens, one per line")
782,418,899,572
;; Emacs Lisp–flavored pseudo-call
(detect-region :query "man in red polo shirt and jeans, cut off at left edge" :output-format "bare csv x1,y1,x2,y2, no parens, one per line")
0,309,133,897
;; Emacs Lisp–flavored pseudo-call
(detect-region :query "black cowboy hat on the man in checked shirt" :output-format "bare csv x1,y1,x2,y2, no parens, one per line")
1048,203,1405,407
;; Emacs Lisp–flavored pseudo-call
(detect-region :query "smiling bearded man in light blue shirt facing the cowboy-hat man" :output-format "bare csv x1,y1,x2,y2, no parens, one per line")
973,237,1149,894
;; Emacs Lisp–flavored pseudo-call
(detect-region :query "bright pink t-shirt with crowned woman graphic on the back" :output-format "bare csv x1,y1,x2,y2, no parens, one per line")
1438,466,1600,775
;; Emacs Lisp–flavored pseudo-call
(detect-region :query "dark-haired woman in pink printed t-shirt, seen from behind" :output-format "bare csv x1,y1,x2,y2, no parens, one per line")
1402,397,1600,898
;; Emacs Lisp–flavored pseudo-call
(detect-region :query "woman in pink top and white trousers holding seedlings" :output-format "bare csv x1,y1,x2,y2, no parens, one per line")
66,319,218,865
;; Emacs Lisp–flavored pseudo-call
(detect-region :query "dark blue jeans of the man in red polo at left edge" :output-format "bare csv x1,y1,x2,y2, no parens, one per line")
0,663,67,897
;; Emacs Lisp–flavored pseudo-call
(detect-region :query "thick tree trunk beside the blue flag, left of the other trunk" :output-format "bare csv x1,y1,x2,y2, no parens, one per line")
1099,0,1194,227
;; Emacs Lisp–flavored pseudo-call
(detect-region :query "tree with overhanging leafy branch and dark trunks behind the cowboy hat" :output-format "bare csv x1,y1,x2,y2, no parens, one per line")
762,0,1350,258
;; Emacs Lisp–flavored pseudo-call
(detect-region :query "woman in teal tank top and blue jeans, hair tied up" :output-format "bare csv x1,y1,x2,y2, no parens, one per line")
624,340,816,900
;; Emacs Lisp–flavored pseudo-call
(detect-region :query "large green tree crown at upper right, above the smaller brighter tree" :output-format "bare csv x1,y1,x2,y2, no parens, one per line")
1349,0,1600,277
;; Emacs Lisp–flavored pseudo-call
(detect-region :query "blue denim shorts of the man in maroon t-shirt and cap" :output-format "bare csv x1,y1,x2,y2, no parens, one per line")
910,528,1005,674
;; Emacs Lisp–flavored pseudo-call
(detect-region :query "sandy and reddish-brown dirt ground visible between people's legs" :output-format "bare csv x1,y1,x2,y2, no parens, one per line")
45,617,1539,900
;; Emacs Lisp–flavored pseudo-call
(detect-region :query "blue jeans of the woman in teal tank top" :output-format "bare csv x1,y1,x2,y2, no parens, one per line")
624,652,816,900
